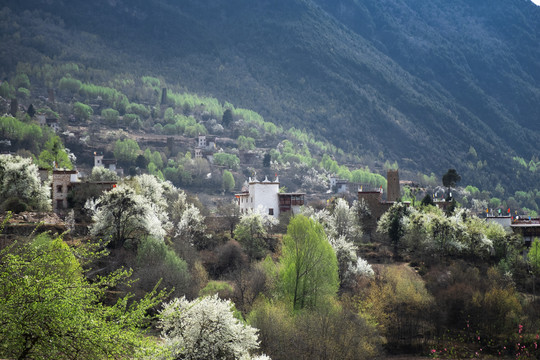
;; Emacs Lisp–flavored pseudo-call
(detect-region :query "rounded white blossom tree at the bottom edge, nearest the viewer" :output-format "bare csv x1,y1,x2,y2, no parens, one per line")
159,295,262,360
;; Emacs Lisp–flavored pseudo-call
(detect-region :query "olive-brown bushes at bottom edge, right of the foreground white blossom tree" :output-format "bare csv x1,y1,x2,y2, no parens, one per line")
248,299,383,360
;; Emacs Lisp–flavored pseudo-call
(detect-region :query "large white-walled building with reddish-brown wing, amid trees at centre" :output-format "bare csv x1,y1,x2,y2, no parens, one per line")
235,177,305,218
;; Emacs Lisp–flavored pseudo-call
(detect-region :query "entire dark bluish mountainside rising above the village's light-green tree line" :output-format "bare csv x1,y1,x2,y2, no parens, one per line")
0,0,540,194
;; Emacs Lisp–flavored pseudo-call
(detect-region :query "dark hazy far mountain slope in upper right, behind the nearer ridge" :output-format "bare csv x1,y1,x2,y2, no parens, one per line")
316,0,540,138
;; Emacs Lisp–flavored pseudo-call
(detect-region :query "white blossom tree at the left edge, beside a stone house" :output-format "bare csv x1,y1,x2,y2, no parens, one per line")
0,155,51,211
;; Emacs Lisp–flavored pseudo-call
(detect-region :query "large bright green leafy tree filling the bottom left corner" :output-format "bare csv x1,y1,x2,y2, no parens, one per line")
0,235,161,359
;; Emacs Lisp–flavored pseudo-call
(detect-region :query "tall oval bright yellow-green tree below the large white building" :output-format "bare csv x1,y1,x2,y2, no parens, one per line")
280,215,339,310
